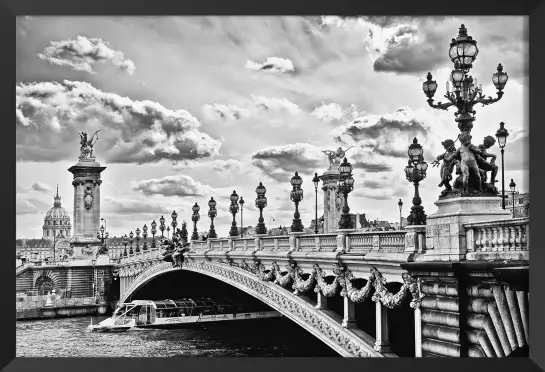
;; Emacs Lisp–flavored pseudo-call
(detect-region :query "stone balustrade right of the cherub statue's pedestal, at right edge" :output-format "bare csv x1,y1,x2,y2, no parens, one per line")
464,218,530,260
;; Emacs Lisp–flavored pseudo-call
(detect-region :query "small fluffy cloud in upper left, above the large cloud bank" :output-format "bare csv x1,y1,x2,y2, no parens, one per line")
38,35,135,75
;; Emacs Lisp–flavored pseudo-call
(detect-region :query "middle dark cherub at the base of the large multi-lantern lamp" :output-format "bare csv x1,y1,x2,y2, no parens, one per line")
445,133,483,193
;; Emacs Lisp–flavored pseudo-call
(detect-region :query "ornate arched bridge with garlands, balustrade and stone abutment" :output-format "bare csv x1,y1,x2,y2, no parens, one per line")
118,218,529,357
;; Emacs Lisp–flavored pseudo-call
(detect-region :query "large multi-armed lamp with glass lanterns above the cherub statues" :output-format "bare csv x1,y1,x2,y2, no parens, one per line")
422,25,508,137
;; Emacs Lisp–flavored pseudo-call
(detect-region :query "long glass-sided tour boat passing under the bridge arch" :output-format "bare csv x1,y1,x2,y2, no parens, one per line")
100,298,282,328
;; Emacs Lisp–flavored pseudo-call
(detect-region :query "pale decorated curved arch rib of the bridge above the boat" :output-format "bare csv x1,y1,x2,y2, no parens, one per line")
120,262,383,357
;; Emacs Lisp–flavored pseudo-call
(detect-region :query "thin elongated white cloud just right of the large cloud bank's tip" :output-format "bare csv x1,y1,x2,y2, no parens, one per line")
203,94,303,121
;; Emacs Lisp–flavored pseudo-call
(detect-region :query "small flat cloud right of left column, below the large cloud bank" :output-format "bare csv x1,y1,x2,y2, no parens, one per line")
133,175,214,197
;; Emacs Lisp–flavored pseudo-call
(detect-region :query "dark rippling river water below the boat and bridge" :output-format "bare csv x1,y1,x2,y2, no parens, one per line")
16,316,338,357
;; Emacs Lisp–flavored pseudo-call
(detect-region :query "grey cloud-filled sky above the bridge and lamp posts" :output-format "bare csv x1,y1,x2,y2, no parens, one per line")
15,16,528,237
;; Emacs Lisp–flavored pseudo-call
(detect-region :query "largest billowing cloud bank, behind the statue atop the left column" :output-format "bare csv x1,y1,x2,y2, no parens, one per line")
15,80,221,164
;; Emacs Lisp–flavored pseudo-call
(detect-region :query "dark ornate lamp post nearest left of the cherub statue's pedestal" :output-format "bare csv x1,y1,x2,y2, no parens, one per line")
405,138,428,225
